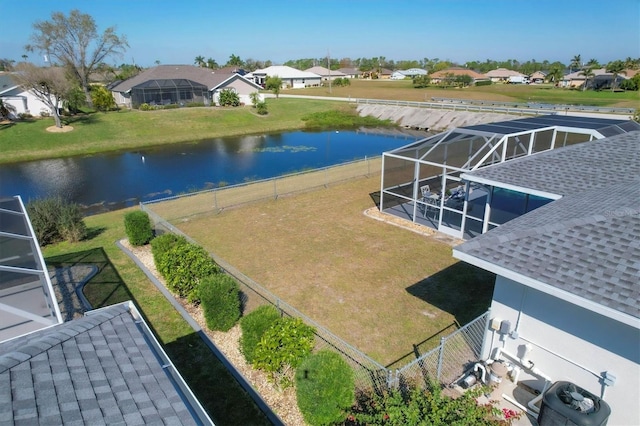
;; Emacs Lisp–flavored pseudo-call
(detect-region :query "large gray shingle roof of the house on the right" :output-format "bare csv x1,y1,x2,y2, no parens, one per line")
454,132,640,318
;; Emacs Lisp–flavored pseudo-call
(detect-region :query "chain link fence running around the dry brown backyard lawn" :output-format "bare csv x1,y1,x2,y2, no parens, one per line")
141,158,488,393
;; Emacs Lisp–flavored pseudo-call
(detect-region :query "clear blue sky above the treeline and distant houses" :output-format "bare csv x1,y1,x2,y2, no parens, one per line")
0,0,640,67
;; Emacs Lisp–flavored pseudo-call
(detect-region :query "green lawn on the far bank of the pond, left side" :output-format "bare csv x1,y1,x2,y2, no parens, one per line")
0,98,348,163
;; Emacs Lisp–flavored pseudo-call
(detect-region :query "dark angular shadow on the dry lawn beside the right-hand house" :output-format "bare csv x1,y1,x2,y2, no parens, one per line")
406,262,495,325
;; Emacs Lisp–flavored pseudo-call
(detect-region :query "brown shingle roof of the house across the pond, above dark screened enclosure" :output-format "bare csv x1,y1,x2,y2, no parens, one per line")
111,65,258,92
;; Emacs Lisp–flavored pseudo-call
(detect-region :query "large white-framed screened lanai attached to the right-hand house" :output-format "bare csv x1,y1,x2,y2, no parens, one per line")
380,115,640,239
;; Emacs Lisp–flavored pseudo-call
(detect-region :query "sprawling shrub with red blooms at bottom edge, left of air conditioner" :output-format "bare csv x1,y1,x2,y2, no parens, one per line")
348,384,508,426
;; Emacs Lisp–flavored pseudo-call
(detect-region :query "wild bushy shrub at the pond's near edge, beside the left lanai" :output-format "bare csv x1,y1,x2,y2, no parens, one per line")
26,197,87,246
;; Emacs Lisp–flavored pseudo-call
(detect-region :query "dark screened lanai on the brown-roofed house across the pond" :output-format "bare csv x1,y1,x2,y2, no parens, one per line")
131,78,210,108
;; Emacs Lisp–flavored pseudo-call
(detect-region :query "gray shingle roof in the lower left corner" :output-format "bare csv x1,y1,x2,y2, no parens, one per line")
0,303,210,425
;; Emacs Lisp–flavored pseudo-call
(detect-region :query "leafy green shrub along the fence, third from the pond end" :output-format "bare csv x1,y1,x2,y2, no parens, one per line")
158,243,219,303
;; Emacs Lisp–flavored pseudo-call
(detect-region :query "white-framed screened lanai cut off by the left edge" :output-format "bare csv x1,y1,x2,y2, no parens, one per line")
0,197,62,341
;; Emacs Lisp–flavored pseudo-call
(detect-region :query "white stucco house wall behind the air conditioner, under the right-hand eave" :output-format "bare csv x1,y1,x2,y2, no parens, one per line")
483,277,640,425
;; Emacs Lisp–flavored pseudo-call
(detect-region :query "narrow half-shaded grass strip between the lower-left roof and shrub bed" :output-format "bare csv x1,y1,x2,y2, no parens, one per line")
43,211,270,426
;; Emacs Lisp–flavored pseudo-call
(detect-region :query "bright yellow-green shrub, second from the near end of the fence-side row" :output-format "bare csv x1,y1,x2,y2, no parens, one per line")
253,317,315,388
